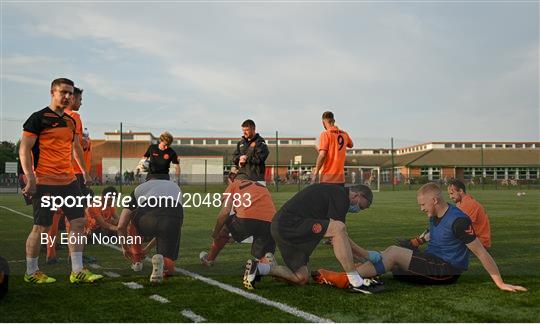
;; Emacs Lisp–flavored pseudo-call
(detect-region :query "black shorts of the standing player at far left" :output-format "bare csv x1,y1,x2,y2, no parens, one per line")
32,180,84,226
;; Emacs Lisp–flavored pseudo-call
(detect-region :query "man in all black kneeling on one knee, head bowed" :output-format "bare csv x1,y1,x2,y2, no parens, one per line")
243,184,381,293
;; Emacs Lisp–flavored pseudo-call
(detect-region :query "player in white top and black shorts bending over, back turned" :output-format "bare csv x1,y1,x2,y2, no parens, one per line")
118,175,184,282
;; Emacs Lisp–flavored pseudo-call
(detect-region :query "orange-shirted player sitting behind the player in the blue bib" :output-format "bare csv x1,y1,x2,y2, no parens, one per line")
396,179,491,249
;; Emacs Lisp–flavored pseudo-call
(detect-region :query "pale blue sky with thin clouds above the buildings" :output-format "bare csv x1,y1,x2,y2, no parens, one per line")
0,1,540,148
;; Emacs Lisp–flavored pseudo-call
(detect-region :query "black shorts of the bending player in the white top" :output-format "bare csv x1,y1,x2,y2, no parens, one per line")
133,206,184,260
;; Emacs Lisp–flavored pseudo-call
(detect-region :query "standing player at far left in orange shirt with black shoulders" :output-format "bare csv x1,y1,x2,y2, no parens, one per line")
19,79,103,284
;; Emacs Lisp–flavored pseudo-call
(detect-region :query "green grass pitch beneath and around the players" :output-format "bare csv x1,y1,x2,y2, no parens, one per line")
0,187,540,322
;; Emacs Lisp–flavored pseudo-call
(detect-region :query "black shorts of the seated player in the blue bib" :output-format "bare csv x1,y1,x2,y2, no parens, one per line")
393,251,463,285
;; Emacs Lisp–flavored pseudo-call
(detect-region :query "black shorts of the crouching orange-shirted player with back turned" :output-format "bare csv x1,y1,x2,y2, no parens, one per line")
225,215,276,259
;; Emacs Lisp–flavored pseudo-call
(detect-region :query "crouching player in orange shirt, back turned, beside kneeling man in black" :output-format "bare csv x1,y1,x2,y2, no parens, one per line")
199,173,276,266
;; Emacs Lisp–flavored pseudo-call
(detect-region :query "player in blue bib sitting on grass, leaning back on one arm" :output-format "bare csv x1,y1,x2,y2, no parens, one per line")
312,183,527,292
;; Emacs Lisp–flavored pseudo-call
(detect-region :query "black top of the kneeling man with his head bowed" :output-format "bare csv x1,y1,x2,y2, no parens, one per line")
276,183,349,223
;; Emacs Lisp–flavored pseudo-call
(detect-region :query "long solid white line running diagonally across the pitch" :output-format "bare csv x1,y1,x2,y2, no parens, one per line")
0,206,332,323
